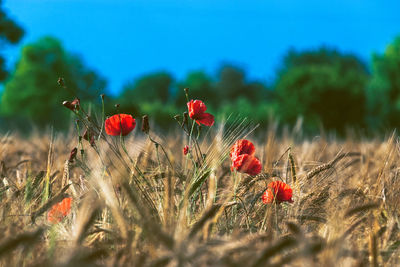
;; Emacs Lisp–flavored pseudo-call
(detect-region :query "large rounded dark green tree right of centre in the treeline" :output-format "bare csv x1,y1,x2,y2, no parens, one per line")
275,48,368,133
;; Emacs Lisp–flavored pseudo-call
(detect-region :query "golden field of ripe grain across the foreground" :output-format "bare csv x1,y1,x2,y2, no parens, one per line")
0,119,400,266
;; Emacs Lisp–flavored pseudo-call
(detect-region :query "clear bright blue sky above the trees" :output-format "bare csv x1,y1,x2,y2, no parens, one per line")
3,0,400,93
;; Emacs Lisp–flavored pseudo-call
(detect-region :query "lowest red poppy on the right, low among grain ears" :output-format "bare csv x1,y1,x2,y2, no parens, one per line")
262,181,293,204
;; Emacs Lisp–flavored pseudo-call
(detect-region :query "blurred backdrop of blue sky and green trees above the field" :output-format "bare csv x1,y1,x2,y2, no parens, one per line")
0,0,400,135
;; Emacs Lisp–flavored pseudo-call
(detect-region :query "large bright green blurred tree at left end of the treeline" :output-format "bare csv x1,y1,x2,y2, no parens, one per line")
1,37,106,128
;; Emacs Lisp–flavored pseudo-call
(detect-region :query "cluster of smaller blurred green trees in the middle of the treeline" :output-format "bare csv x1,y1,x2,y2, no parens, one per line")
117,65,271,129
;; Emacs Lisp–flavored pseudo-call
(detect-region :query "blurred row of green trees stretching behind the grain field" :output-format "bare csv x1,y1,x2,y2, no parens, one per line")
0,37,400,134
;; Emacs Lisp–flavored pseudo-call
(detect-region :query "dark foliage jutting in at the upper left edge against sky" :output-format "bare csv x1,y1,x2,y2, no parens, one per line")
0,0,24,81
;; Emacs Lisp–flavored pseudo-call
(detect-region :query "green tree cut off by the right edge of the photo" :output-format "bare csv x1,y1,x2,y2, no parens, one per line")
368,36,400,129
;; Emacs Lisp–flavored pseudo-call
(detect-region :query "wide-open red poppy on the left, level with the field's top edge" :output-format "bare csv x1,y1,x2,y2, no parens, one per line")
105,114,136,136
